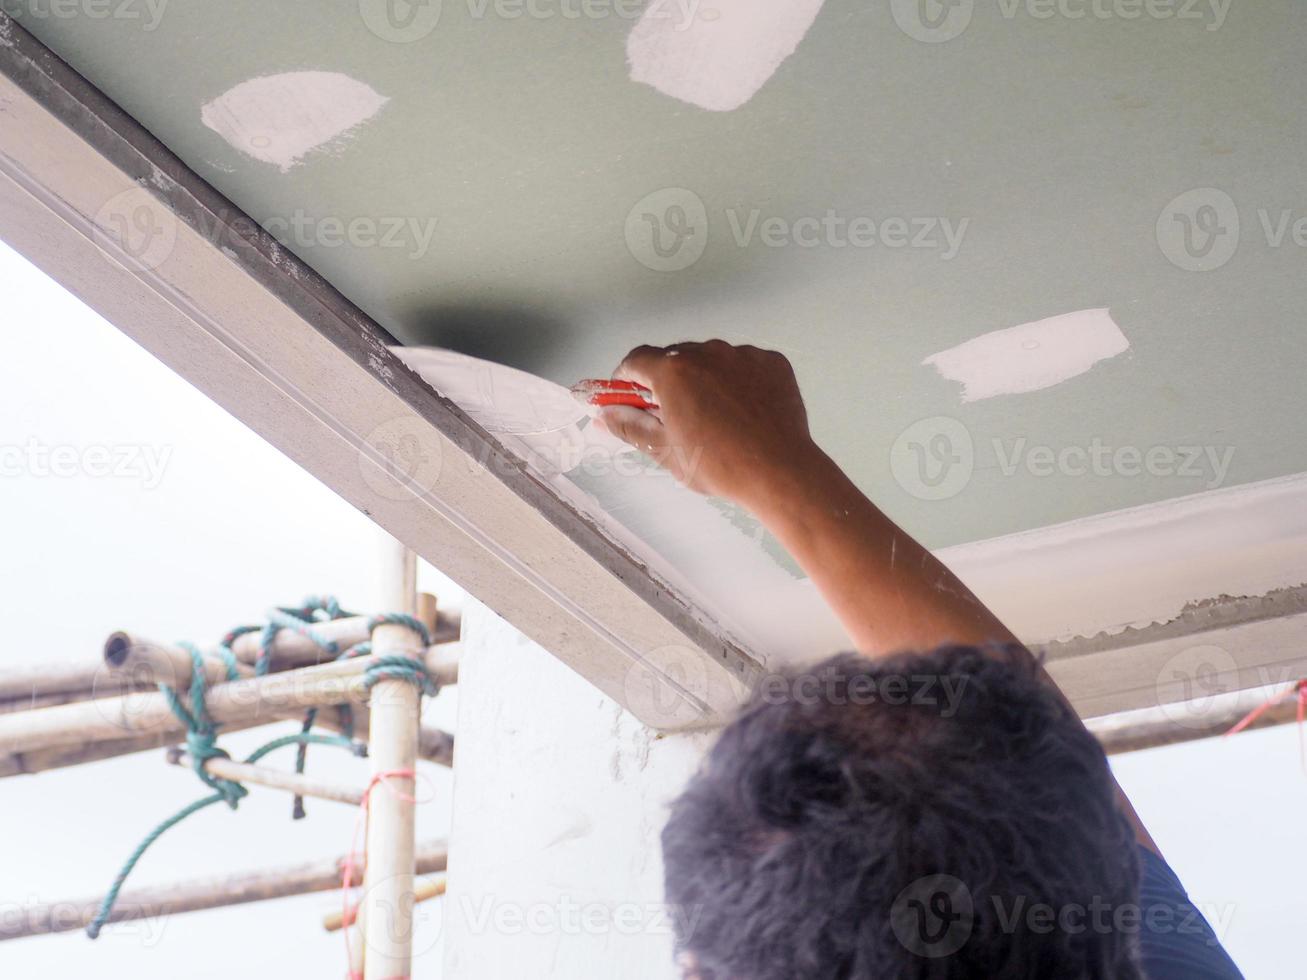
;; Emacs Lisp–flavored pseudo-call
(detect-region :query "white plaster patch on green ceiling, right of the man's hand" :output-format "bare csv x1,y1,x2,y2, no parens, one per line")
921,308,1131,402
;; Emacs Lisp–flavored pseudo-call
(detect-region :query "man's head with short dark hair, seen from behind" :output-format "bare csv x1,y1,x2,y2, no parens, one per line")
663,647,1140,980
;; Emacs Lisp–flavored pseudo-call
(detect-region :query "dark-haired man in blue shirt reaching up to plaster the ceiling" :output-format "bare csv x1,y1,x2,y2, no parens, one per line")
597,341,1239,980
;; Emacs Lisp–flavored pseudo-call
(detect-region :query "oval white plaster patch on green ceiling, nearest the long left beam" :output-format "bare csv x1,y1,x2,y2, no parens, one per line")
200,72,389,172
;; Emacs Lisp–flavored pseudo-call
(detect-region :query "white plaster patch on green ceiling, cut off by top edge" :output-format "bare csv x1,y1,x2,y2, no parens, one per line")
626,0,823,112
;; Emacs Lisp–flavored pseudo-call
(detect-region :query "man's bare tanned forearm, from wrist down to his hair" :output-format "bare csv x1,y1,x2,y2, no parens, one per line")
744,447,1014,656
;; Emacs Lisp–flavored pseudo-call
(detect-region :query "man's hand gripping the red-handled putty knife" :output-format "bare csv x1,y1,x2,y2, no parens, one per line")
599,340,816,507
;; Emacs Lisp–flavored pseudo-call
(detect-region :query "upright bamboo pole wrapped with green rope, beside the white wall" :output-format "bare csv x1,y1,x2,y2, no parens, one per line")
361,541,422,980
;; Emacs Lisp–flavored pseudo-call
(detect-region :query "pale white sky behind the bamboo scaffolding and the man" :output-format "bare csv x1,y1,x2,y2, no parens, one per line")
0,243,1307,980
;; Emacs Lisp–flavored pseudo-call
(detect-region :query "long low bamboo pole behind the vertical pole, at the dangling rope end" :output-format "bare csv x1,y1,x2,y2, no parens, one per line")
0,840,448,941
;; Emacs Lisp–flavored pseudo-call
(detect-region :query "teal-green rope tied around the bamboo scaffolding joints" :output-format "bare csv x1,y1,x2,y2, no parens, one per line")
86,596,439,939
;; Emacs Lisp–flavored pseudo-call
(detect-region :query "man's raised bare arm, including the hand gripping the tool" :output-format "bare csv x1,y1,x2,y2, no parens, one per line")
600,341,1157,851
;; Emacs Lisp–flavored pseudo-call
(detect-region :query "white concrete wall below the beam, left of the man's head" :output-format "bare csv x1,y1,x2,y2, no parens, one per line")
443,600,710,980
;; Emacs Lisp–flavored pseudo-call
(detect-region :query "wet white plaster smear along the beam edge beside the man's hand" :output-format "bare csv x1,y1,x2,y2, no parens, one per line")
392,348,850,666
